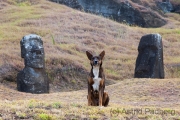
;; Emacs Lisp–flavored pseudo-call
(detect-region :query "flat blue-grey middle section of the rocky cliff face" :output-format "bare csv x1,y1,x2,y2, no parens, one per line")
78,0,146,27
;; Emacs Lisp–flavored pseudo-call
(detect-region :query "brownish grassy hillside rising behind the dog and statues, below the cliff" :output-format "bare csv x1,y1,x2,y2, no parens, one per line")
0,0,180,91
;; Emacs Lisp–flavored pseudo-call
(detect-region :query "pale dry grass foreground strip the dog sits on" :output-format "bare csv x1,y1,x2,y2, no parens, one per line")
0,79,180,120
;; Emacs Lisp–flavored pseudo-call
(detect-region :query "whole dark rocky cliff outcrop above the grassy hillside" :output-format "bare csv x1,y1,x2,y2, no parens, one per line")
51,0,179,27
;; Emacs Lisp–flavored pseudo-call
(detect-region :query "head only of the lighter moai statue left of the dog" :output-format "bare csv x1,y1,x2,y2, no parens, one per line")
20,34,44,68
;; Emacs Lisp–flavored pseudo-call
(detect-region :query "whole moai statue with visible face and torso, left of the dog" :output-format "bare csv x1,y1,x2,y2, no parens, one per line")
17,34,49,94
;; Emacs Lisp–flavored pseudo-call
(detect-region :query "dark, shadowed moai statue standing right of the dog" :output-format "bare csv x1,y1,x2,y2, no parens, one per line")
134,34,164,79
